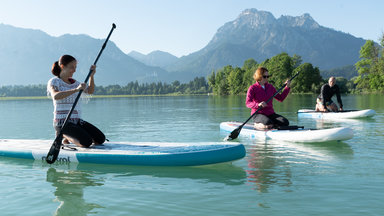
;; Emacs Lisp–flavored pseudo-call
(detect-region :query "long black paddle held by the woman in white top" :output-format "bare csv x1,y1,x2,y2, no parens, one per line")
45,23,116,164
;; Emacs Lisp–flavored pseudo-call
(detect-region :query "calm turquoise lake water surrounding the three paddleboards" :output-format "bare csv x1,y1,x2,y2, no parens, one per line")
0,95,384,216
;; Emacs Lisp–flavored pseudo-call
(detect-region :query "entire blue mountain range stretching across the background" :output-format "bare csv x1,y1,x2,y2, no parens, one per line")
0,9,365,85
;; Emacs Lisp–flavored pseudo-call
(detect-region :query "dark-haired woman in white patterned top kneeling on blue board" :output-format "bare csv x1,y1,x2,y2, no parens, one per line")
47,55,105,147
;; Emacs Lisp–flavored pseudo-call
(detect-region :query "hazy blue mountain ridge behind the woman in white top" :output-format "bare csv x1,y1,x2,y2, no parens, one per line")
0,24,168,85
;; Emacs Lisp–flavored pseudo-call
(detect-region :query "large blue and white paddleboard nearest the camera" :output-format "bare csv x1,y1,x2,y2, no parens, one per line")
0,139,245,166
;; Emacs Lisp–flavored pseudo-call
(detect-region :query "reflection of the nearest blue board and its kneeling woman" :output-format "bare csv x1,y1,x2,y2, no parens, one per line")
40,162,246,216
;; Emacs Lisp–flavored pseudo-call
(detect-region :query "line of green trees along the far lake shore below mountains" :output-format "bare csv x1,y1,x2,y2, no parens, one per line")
0,37,384,98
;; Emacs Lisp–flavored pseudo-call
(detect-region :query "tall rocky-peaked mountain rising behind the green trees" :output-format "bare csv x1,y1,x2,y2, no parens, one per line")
161,9,365,81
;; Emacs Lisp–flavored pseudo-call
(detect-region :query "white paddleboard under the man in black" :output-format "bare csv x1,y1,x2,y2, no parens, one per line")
297,109,376,120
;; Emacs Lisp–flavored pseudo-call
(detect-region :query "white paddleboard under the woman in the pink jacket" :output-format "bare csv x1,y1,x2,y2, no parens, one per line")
220,122,353,143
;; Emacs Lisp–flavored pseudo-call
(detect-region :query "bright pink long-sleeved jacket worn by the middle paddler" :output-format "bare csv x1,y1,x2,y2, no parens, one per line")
245,82,290,116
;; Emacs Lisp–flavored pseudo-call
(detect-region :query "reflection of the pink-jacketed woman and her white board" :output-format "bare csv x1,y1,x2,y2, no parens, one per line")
246,140,353,193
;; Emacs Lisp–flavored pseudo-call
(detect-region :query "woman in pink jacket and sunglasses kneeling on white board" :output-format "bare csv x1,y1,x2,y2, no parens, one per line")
245,67,291,129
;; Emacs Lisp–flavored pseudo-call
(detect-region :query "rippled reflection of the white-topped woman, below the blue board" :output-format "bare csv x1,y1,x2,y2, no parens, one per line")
47,167,103,216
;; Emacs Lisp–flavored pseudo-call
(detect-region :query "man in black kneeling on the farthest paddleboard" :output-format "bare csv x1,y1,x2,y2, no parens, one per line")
316,77,343,112
